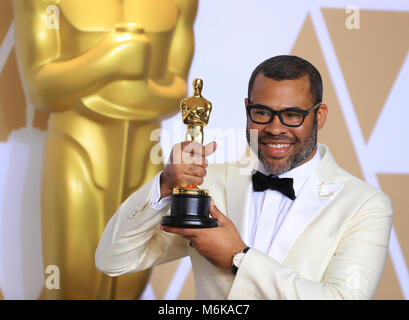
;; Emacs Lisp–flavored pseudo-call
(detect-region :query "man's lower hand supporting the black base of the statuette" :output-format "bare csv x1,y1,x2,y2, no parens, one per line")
161,200,247,270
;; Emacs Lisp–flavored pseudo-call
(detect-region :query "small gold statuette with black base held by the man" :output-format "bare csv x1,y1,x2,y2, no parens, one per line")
162,79,218,228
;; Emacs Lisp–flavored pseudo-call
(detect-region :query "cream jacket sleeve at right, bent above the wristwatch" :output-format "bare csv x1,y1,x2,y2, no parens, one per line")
228,193,393,300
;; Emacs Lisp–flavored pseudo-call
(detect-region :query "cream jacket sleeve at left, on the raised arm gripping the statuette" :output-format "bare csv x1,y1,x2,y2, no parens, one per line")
95,174,188,276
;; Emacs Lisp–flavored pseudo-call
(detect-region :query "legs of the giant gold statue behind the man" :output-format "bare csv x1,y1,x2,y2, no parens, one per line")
41,111,161,299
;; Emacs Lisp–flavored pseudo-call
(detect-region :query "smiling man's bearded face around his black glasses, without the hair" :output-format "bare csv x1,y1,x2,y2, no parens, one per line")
245,73,327,175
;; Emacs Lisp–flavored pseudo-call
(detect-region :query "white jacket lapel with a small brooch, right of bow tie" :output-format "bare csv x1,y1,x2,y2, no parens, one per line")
268,145,344,263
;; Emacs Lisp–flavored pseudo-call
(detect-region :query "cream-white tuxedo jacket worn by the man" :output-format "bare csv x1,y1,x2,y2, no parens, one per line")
95,145,393,299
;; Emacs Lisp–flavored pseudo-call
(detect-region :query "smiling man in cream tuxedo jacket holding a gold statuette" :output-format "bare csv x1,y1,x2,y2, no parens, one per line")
96,56,393,299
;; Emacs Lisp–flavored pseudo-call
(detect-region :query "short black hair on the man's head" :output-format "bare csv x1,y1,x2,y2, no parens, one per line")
248,55,322,104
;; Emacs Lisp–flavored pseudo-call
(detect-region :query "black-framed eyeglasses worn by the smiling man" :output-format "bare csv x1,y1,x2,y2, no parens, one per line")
246,100,322,127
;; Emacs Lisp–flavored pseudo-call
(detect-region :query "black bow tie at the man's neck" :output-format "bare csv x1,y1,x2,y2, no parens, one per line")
252,171,295,200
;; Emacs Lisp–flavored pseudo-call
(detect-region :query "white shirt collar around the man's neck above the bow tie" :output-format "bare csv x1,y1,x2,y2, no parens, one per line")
258,148,321,195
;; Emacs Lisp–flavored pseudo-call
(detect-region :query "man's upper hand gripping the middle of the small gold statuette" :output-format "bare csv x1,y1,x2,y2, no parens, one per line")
160,141,216,198
